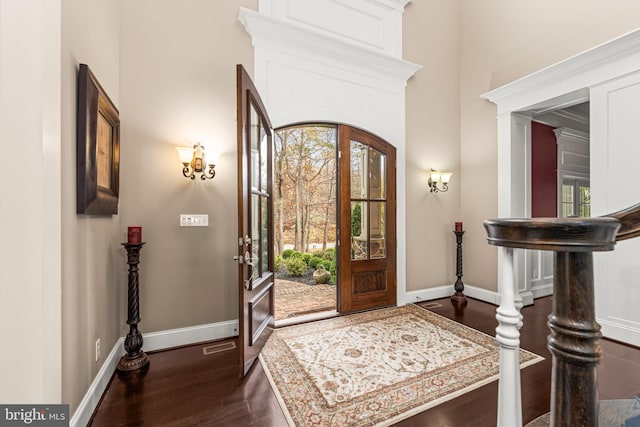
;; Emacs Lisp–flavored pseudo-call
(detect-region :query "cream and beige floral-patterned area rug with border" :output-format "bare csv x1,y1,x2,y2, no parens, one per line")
260,304,543,427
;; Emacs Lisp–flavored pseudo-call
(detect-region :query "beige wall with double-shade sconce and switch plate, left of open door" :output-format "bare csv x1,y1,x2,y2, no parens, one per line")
117,0,257,335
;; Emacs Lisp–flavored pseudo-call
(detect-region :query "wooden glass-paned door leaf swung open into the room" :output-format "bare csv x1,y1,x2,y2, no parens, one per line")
235,65,275,376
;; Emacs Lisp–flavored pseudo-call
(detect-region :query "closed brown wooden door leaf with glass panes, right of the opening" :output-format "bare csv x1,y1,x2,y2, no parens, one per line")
338,125,396,313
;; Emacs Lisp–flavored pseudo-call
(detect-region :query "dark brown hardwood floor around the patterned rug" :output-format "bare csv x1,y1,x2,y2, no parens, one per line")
90,298,640,427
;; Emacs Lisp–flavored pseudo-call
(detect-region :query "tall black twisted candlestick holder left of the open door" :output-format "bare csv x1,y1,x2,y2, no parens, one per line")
118,243,149,372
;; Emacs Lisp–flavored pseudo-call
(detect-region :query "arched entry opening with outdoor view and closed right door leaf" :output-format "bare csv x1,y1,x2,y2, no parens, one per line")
273,123,397,325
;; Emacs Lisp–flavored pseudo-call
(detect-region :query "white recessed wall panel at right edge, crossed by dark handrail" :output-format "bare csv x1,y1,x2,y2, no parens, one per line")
591,72,640,346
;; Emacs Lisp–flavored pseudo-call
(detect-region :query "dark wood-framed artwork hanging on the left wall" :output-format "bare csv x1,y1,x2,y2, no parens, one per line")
76,64,120,215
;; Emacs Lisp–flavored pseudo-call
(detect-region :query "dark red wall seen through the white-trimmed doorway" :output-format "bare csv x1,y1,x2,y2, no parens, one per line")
531,122,558,218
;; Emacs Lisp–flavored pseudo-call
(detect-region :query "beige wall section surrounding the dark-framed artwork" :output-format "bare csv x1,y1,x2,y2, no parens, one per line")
61,0,123,413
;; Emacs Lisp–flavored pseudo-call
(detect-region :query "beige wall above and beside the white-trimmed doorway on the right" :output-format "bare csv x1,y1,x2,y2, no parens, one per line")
460,0,640,290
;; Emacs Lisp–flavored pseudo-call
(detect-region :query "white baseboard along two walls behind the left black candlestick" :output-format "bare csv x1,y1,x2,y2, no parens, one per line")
69,320,238,427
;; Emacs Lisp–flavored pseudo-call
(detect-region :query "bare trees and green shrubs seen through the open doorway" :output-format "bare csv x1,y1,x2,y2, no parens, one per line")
273,125,337,283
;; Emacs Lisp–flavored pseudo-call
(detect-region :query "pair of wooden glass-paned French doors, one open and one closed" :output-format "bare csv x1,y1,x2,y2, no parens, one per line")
235,65,396,370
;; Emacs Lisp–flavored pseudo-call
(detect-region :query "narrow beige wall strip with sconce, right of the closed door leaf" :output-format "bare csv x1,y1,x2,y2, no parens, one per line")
398,0,461,291
